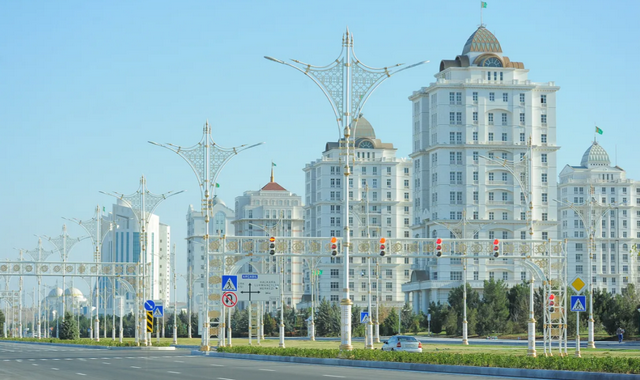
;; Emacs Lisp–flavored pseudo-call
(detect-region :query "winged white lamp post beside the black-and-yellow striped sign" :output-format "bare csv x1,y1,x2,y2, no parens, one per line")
101,176,183,346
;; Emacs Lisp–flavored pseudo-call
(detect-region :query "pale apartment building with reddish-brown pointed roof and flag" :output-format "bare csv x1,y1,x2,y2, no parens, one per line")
233,170,304,311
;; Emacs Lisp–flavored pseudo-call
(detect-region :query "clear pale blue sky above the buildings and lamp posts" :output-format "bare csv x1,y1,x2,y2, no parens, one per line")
0,0,640,300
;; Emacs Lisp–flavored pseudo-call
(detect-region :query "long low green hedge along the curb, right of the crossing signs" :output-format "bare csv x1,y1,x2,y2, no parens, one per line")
218,346,640,374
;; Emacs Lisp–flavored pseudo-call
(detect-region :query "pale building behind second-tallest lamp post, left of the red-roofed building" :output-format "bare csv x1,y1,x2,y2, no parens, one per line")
187,196,235,312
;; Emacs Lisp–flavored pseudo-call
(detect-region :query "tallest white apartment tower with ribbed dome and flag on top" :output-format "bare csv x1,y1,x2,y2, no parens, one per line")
403,26,559,313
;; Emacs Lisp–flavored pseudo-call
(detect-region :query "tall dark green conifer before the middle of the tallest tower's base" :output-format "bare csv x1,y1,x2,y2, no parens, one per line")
476,278,509,335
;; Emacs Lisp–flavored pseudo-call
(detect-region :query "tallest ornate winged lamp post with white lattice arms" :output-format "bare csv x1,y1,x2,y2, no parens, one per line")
264,28,428,350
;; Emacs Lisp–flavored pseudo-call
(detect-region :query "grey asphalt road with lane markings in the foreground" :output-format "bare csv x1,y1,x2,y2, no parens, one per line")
0,342,536,380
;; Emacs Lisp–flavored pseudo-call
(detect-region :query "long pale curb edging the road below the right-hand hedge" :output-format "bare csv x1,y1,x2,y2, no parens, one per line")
191,350,638,380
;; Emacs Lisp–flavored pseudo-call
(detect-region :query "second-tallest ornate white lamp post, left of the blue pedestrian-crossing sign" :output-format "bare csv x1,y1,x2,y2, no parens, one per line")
149,121,263,351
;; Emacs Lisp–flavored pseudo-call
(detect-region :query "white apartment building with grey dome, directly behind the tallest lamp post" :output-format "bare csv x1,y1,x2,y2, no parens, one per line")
303,117,412,307
